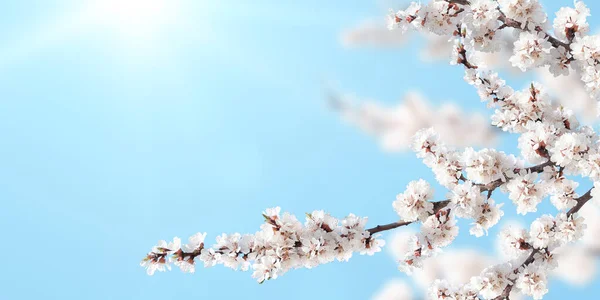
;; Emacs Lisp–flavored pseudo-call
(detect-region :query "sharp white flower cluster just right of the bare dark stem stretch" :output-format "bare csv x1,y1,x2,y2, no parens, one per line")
393,129,521,273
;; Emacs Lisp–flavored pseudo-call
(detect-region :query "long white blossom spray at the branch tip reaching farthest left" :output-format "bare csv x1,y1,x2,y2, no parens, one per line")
141,207,385,282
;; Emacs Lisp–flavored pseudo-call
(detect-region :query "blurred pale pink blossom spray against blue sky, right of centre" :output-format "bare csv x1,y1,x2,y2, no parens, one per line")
331,92,496,152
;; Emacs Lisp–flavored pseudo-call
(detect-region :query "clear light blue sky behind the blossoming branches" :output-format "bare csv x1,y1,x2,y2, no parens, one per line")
0,0,600,300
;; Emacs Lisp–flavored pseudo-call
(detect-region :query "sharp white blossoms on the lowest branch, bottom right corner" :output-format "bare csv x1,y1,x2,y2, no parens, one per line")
429,213,585,299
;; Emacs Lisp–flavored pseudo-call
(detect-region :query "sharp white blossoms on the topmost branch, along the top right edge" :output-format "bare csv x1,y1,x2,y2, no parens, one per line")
388,0,600,106
